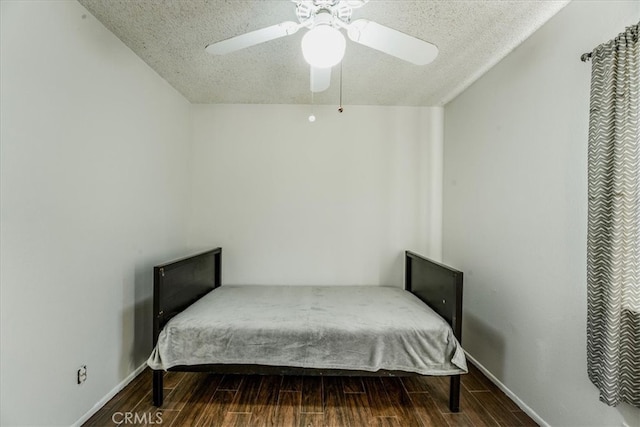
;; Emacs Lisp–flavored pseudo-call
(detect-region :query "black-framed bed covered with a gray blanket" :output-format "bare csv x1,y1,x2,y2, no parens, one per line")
147,248,467,412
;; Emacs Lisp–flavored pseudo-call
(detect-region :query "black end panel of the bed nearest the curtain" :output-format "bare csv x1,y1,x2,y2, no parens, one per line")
404,251,463,342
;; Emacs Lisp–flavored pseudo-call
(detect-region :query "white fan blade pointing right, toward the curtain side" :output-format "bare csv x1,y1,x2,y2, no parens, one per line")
348,19,438,65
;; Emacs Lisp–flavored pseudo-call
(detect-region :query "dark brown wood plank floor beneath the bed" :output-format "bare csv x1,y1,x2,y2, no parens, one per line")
84,366,537,427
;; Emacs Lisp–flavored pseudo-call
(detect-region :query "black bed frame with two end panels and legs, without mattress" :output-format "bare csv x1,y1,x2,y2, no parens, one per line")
153,248,463,412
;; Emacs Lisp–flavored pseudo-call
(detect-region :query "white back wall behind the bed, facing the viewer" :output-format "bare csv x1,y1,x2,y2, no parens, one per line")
190,105,442,285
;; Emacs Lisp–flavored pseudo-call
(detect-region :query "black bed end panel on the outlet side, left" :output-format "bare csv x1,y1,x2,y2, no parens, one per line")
153,248,222,346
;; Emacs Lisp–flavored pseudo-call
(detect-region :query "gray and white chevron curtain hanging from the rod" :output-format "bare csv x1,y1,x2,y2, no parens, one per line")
587,23,640,407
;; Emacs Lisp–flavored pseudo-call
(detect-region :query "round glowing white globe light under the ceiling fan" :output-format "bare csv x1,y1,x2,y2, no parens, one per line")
302,25,347,68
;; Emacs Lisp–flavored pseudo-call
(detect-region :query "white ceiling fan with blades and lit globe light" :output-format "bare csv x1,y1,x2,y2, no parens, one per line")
206,0,438,92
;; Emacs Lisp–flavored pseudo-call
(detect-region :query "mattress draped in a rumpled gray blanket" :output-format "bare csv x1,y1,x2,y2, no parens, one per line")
147,285,467,375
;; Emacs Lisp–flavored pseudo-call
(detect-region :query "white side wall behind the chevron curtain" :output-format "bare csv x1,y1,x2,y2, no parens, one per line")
443,1,640,426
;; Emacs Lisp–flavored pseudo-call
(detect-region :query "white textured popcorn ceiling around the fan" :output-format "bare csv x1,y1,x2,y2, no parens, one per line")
79,0,569,106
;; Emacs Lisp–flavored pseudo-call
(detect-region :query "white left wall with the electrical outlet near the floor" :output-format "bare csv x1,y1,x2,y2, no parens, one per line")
0,1,191,426
